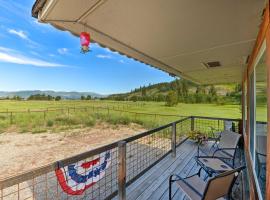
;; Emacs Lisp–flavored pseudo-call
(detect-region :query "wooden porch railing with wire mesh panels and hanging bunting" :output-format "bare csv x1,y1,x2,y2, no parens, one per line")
0,116,239,200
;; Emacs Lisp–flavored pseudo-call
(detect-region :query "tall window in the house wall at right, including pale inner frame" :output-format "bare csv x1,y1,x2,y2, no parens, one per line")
248,43,267,199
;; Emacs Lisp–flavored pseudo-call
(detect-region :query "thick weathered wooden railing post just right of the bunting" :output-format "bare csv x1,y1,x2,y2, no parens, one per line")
118,141,126,200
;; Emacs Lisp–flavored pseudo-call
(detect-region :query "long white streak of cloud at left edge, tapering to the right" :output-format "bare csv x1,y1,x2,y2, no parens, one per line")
0,47,67,67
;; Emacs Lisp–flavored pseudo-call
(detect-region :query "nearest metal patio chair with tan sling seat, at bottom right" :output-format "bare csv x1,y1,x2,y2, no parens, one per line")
169,166,245,200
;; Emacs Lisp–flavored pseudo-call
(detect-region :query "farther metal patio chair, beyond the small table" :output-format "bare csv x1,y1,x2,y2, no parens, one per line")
197,130,241,166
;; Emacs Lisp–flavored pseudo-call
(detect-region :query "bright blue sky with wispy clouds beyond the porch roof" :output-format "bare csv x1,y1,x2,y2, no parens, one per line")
0,0,173,94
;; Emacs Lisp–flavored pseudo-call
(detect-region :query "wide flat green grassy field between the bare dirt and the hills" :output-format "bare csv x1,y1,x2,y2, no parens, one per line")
0,100,266,133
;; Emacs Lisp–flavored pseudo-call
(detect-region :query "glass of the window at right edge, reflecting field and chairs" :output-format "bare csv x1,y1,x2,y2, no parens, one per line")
255,50,267,196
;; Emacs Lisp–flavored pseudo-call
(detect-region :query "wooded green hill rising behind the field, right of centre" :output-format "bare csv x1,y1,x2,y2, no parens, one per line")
106,79,240,103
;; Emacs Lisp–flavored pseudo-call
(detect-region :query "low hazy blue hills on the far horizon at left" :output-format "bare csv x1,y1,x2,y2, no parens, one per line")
0,90,106,99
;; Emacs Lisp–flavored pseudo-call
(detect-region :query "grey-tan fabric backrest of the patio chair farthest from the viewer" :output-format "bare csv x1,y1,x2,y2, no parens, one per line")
218,130,241,148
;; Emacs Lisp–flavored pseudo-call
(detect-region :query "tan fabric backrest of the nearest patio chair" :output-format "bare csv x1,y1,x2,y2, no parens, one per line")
203,166,245,200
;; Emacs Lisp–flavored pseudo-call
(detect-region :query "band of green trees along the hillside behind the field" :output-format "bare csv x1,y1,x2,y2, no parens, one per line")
106,79,241,106
